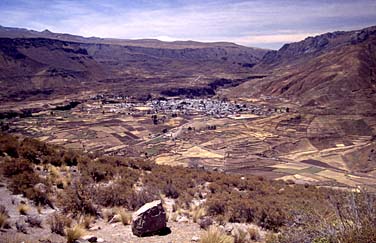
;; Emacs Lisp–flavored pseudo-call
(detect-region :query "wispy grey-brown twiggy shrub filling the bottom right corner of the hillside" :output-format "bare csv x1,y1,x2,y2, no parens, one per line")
280,191,376,243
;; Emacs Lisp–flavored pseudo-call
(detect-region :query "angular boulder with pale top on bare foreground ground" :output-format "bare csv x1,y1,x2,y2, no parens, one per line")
132,200,166,236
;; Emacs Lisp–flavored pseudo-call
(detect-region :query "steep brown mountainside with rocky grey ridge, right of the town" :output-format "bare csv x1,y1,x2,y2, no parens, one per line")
229,26,376,113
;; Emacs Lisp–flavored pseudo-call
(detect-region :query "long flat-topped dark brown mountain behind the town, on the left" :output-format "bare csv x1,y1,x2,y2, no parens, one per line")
0,27,267,101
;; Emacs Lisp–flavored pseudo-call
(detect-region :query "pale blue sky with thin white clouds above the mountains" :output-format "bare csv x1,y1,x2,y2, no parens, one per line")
0,0,376,49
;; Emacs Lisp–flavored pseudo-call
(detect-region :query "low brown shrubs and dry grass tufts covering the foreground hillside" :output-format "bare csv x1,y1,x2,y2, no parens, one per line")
0,133,376,243
